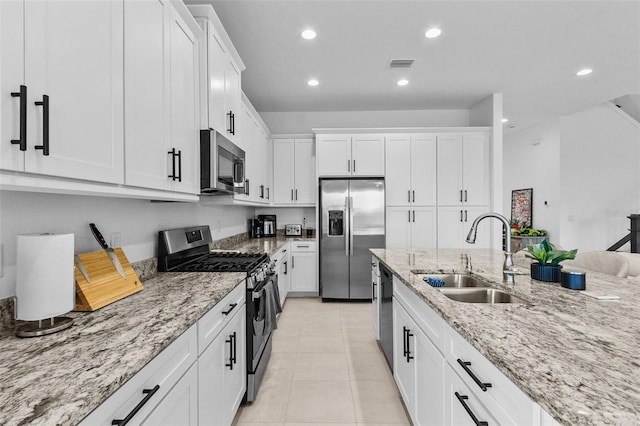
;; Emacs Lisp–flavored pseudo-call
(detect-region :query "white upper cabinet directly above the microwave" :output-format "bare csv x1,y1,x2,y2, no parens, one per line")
188,5,245,144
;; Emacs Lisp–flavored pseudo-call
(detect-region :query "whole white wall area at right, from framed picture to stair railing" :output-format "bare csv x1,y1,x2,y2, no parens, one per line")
504,104,640,251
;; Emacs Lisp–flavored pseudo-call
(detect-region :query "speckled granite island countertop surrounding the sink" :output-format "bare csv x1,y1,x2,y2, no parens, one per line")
371,249,640,425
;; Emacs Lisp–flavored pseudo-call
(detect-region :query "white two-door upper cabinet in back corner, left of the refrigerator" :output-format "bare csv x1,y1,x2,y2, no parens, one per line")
273,138,316,205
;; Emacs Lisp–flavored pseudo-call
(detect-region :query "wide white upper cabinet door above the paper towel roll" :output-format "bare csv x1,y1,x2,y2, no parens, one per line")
22,0,124,183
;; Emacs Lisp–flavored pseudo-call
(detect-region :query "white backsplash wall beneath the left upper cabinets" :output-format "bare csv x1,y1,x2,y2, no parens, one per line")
0,191,254,299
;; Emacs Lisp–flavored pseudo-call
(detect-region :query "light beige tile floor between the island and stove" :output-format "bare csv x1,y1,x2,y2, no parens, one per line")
234,298,410,426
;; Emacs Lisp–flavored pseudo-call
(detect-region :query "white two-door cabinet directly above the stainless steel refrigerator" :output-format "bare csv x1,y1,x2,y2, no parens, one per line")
316,135,384,177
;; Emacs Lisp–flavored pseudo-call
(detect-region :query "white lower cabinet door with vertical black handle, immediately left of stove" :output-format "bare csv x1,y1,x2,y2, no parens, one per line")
198,305,246,426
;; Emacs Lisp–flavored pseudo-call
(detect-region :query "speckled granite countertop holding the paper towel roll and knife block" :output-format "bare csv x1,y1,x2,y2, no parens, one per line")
0,273,246,425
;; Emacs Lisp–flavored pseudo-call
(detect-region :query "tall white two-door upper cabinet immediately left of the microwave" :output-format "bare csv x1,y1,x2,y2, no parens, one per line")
124,0,200,194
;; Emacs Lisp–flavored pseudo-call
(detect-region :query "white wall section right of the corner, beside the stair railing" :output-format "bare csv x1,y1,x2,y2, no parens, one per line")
559,103,640,251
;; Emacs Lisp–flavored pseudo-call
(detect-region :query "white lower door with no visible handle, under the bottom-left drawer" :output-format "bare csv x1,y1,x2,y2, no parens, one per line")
141,364,198,426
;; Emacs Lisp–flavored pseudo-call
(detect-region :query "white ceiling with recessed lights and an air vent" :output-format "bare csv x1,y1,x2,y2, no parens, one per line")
189,0,640,129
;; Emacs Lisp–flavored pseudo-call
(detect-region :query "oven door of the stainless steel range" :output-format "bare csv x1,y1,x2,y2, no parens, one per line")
247,274,278,372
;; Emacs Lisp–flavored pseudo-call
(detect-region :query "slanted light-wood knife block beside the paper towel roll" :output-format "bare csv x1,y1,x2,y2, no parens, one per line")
74,248,143,311
